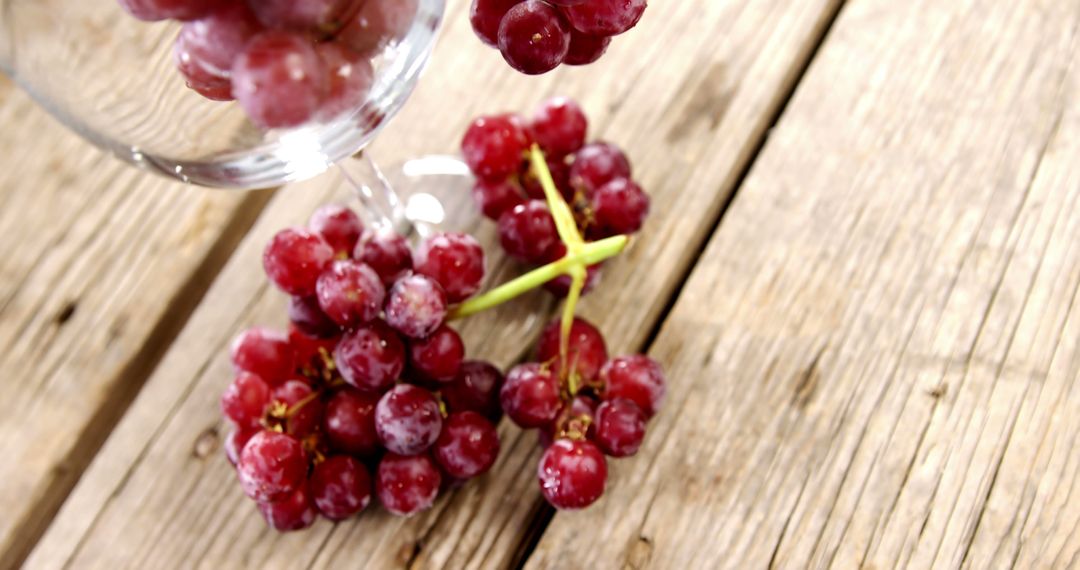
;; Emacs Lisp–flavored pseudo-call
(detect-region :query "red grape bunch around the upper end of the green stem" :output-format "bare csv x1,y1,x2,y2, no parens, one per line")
461,97,649,297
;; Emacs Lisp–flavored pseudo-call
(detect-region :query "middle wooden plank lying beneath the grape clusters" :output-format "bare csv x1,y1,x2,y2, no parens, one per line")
21,0,837,568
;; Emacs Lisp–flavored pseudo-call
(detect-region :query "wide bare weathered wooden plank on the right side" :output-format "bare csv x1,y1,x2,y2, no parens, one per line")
527,0,1080,568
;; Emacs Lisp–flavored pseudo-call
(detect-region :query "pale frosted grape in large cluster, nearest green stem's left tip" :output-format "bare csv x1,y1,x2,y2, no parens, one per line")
386,273,447,338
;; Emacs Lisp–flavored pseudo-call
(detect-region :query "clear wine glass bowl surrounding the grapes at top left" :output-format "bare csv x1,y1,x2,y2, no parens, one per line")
0,0,445,189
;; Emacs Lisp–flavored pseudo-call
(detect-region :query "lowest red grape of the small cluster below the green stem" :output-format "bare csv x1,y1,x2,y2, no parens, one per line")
537,439,607,510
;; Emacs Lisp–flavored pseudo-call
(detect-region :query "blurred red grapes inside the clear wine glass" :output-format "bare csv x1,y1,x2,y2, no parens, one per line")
119,0,418,128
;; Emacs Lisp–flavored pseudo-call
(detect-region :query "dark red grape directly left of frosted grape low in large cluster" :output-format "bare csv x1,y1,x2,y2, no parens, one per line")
323,388,379,457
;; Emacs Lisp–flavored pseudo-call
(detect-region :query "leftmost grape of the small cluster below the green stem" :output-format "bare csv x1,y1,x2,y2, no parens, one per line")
499,363,563,429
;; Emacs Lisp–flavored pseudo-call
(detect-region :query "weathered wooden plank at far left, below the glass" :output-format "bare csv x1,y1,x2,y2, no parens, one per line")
0,78,265,567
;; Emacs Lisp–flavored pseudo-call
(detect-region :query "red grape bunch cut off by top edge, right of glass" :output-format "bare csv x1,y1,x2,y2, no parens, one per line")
469,0,647,76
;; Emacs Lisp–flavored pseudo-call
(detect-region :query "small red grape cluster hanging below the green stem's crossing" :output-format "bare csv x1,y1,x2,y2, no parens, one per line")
499,318,666,510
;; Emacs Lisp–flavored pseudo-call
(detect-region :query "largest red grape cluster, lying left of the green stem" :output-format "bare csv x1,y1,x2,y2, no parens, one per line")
221,205,503,531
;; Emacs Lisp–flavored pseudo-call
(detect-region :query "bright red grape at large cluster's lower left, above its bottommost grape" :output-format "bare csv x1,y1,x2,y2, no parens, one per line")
237,430,308,502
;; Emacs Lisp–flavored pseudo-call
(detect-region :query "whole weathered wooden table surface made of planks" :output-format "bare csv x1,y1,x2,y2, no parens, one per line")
0,0,1080,569
